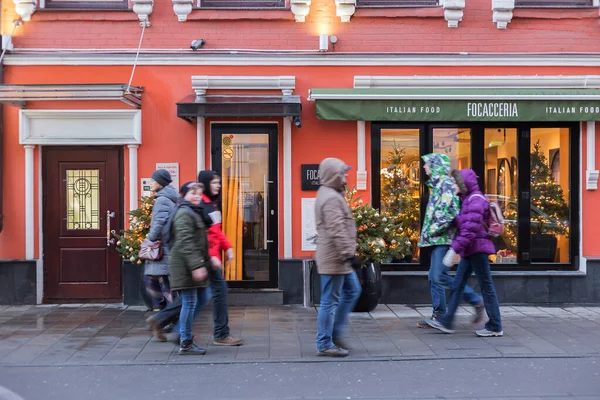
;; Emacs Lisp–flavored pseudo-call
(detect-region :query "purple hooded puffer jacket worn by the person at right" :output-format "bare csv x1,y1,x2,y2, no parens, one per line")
452,169,496,258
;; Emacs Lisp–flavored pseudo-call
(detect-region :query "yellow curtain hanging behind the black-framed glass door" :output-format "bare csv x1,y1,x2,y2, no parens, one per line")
223,145,244,280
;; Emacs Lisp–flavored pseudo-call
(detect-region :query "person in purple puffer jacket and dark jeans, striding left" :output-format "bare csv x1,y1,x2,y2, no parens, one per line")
427,169,503,337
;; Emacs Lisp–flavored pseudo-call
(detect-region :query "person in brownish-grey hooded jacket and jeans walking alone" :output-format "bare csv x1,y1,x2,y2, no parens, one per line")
315,158,361,357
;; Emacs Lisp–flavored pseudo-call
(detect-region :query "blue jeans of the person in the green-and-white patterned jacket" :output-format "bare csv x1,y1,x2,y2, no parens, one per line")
429,246,482,315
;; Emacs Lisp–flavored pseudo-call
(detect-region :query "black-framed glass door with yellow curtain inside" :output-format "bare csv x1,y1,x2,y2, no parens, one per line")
212,124,278,287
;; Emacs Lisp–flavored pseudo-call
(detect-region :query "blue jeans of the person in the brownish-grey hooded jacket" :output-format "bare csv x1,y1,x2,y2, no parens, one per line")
317,272,361,351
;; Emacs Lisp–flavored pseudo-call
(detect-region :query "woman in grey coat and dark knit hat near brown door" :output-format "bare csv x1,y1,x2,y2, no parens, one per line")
144,169,179,311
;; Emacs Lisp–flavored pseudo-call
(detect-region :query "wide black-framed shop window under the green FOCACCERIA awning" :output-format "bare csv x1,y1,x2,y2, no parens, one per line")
371,123,579,270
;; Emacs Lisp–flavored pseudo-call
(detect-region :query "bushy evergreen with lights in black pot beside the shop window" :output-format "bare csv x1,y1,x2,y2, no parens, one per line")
346,189,411,312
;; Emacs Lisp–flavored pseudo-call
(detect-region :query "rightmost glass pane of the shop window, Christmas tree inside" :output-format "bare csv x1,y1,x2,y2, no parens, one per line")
529,128,571,263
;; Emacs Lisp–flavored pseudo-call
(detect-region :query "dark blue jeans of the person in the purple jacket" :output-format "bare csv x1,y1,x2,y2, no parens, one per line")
438,253,502,332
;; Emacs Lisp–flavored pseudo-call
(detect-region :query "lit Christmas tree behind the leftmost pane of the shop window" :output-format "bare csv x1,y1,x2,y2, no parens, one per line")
381,141,421,259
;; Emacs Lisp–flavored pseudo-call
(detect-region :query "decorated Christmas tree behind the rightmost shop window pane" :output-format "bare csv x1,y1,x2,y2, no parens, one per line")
531,140,569,236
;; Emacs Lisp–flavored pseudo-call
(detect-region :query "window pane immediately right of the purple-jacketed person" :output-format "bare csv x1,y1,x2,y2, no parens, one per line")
481,128,519,264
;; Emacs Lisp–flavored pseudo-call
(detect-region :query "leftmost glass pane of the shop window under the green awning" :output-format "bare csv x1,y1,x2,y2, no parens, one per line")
379,129,421,262
